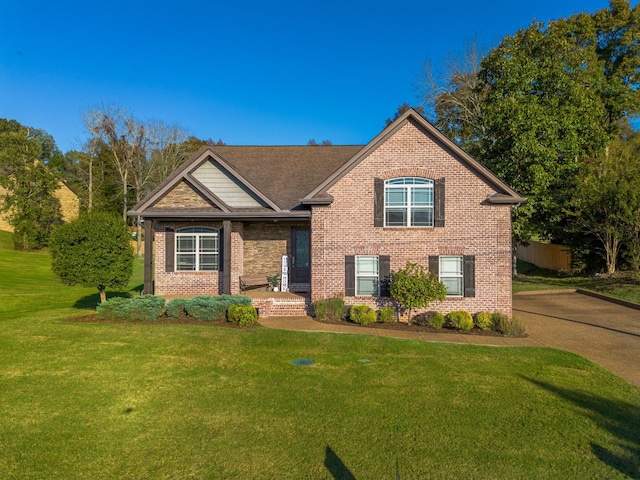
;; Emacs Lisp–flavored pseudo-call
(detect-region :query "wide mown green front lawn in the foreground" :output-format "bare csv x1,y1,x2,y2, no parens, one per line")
0,231,640,479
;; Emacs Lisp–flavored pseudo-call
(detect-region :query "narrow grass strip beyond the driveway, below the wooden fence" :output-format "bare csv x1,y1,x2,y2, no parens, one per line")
513,261,640,303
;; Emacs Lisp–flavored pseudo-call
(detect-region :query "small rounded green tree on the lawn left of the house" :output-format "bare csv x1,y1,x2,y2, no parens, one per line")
50,212,134,302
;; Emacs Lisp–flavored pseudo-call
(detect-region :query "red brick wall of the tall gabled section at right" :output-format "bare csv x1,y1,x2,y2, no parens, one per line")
311,118,511,315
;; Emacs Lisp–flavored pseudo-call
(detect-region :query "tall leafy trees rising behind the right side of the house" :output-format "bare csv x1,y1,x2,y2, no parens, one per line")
419,0,640,273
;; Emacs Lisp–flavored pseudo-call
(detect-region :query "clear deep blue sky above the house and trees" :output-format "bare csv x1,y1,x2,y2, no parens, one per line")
0,0,608,151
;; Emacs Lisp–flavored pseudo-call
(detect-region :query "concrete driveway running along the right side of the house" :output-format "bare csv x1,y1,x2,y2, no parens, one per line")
513,291,640,387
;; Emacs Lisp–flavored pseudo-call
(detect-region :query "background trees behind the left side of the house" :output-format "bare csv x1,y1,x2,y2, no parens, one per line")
0,106,224,253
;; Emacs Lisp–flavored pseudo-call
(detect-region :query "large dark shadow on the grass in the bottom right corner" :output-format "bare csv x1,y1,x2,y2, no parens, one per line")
524,377,640,478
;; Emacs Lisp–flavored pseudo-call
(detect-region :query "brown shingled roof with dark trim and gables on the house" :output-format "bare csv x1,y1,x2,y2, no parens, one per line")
129,109,526,218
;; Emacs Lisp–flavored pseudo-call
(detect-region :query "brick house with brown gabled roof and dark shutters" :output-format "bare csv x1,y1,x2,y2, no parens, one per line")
129,110,525,315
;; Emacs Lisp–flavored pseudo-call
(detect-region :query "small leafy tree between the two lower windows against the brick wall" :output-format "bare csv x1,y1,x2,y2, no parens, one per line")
390,262,447,324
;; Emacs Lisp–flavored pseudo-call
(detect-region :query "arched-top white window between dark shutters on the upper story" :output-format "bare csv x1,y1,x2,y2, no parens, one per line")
384,177,433,227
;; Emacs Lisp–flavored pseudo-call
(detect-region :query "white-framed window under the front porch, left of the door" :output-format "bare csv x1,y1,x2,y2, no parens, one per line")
175,227,220,272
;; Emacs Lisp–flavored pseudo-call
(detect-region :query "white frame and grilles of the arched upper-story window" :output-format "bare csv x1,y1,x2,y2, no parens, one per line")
384,177,435,228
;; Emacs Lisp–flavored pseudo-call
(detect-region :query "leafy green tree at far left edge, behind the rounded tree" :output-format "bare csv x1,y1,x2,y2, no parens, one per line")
0,119,61,250
